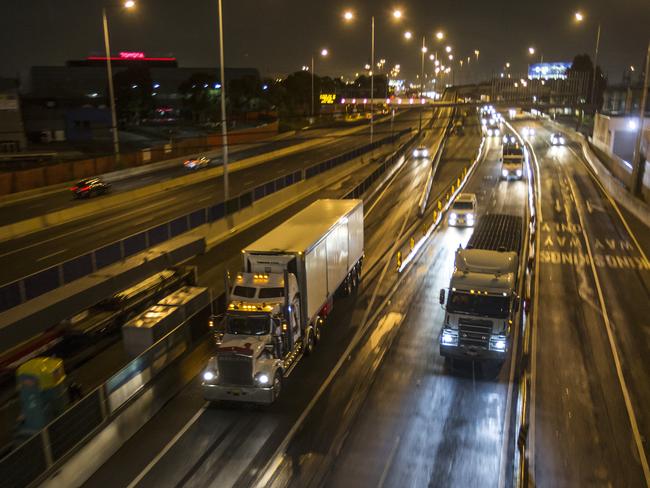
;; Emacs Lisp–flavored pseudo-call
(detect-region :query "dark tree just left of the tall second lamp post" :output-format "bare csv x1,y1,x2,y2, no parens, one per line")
178,73,221,122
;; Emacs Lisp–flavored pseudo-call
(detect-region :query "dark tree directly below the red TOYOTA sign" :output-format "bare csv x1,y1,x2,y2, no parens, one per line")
113,64,153,124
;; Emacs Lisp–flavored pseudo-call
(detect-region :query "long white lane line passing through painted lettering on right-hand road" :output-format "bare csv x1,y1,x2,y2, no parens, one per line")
567,171,650,487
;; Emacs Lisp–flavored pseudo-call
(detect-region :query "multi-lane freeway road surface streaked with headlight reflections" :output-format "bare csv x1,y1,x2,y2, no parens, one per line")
2,104,650,487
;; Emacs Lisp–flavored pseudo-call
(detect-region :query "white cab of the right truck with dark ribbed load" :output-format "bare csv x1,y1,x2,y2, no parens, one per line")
440,248,519,362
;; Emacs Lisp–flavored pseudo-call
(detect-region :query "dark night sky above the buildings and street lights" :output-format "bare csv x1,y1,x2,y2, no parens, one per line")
0,0,650,82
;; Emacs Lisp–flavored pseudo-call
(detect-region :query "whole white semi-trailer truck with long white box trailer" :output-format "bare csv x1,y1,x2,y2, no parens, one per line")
201,200,363,404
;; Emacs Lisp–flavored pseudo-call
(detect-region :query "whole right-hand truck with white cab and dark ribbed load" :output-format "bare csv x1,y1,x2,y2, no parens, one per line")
439,214,522,362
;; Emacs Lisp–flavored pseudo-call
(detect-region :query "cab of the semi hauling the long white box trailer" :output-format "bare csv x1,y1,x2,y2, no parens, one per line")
202,273,304,403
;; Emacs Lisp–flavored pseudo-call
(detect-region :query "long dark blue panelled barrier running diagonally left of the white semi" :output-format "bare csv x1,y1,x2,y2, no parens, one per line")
0,129,411,312
